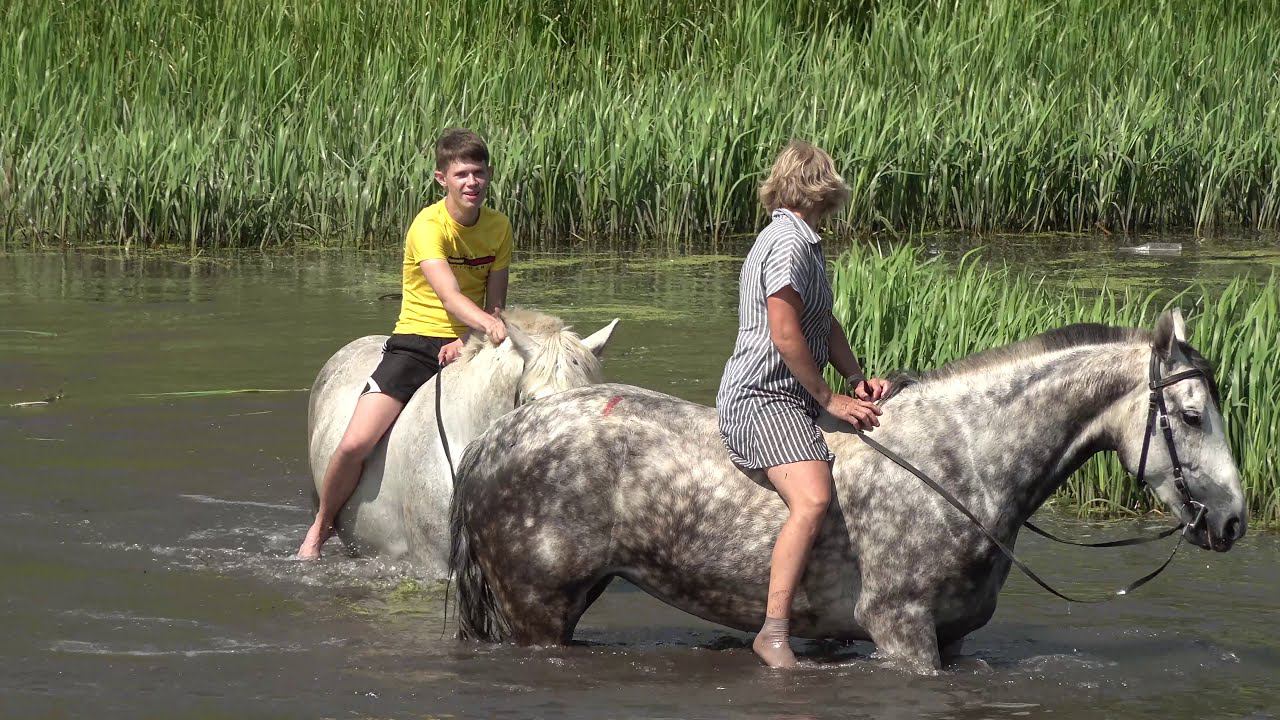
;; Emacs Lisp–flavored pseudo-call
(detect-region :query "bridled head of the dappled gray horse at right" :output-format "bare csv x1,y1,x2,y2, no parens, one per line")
1121,310,1247,552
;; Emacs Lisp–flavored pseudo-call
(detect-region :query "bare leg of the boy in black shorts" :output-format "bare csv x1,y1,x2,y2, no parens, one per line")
298,392,404,560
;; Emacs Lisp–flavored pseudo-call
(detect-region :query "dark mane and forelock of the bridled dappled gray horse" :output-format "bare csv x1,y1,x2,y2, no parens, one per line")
890,323,1221,406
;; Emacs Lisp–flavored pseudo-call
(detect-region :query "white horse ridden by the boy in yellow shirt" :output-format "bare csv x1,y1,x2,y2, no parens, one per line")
307,309,618,578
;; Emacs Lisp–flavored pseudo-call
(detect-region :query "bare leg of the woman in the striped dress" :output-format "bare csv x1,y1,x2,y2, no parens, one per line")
751,460,831,667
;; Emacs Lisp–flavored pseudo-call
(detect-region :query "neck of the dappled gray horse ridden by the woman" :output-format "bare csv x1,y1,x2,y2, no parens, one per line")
901,343,1149,533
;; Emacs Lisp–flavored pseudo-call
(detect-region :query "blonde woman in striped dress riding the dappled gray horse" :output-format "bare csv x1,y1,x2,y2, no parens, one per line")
716,141,890,667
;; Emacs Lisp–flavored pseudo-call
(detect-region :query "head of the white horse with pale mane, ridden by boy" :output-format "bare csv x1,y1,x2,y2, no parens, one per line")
466,309,618,405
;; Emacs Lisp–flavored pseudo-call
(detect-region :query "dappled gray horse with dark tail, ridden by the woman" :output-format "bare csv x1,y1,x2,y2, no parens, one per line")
452,313,1245,671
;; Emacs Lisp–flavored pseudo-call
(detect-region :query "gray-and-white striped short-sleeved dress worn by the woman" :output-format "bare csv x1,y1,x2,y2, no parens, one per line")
716,209,836,469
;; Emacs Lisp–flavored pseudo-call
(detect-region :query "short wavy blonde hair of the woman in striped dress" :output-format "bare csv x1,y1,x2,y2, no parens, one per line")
759,140,849,220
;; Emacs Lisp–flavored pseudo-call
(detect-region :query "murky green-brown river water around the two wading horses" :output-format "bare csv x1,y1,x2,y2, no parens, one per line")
0,238,1280,720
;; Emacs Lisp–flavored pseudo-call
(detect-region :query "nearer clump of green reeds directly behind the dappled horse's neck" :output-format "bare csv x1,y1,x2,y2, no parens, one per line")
833,247,1280,527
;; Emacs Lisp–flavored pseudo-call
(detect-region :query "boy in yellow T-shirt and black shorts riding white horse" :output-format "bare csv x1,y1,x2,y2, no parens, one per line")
298,128,511,560
